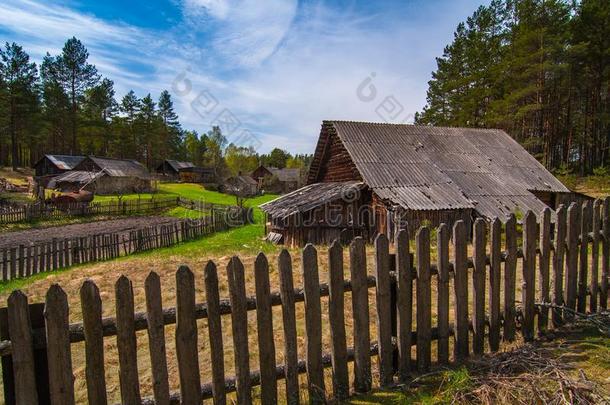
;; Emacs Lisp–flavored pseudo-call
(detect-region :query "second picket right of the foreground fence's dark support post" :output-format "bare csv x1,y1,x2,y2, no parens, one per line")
415,227,432,372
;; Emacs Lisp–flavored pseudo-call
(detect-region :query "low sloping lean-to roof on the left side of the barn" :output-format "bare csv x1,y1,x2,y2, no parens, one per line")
260,181,365,218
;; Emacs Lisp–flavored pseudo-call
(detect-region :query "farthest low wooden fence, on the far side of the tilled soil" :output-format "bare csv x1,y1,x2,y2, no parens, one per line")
0,197,180,224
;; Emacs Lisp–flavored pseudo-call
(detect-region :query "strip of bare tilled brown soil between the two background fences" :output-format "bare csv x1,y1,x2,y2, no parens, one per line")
0,216,178,248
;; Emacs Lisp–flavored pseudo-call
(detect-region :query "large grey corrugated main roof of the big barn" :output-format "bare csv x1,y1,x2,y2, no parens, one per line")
266,121,569,218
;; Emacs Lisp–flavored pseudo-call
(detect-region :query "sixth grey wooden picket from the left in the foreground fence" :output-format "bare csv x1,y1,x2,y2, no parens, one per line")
176,266,201,405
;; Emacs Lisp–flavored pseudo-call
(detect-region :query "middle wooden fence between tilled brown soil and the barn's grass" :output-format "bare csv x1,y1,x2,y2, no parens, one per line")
0,207,247,281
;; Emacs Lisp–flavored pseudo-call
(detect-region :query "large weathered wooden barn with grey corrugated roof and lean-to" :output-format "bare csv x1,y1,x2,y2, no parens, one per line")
261,121,569,246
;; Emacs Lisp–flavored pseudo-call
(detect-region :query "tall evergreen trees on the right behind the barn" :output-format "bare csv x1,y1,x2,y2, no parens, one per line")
416,0,610,175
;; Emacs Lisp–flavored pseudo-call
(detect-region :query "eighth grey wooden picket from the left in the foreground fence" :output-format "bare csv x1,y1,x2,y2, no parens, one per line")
227,256,252,404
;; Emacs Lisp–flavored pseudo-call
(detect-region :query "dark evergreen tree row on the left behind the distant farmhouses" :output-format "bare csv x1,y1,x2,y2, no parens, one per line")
0,38,205,168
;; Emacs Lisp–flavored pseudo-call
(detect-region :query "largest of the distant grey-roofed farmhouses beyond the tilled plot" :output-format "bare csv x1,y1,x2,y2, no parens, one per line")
48,156,152,194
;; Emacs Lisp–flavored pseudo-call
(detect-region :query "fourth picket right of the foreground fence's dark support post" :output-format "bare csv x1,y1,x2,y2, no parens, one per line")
448,220,469,361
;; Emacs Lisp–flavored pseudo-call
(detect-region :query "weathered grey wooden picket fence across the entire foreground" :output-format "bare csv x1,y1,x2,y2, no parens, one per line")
0,200,610,405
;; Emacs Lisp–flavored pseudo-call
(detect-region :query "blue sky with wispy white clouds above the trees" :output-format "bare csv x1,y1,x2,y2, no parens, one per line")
0,0,484,153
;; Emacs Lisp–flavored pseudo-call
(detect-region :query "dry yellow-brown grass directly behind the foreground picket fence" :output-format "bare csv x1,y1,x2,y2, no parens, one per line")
0,240,604,403
